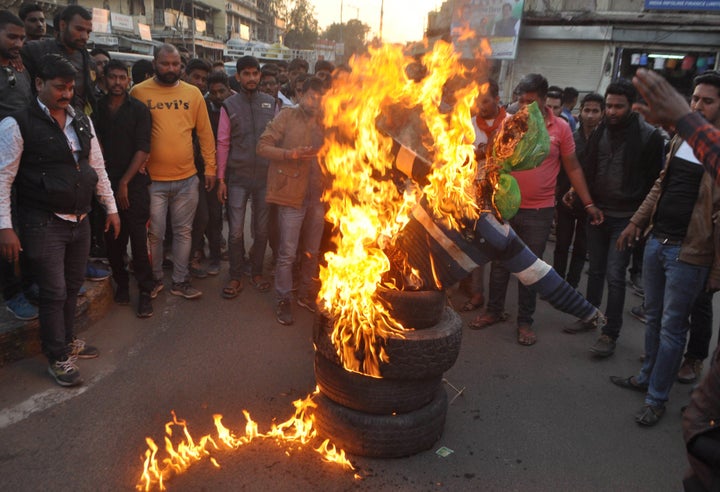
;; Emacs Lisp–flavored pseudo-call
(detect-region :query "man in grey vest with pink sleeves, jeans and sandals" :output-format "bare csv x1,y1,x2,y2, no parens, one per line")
217,56,275,299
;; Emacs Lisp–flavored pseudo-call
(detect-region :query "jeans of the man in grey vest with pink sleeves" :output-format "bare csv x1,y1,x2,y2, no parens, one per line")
227,173,269,280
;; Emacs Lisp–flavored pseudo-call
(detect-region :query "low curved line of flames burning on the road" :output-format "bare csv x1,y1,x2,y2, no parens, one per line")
136,389,352,491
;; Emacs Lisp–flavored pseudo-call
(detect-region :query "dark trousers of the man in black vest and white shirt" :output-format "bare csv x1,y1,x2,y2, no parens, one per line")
18,211,90,361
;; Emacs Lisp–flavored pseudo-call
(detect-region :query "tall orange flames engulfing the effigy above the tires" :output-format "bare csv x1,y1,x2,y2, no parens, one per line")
320,42,490,377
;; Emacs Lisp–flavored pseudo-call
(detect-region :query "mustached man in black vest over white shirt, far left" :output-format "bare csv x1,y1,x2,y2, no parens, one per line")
0,54,120,386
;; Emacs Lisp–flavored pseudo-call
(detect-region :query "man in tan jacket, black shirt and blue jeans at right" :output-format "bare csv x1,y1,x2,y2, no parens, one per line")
610,72,720,426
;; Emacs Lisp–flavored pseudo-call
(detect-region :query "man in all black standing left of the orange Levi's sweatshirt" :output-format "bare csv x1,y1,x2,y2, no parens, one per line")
93,60,155,318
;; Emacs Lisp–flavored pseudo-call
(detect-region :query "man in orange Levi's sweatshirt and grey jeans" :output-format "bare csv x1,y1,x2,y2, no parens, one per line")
130,44,215,299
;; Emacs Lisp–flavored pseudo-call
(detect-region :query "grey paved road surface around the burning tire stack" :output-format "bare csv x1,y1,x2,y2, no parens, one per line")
0,246,715,492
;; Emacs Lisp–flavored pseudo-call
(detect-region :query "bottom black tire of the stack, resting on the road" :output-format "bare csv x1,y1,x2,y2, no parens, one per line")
313,386,448,458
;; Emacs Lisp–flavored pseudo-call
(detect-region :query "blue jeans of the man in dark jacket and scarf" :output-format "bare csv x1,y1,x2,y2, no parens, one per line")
586,216,631,340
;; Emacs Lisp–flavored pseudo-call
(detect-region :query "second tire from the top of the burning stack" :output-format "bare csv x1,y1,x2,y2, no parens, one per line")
315,307,463,379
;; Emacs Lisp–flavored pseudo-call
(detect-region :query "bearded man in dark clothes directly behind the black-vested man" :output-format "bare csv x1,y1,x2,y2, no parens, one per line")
21,5,95,114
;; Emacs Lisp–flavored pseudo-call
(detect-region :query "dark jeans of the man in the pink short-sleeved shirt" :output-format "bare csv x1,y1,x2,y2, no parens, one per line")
487,207,555,324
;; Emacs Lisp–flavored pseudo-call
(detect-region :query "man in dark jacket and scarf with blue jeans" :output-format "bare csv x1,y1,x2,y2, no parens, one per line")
564,81,664,357
